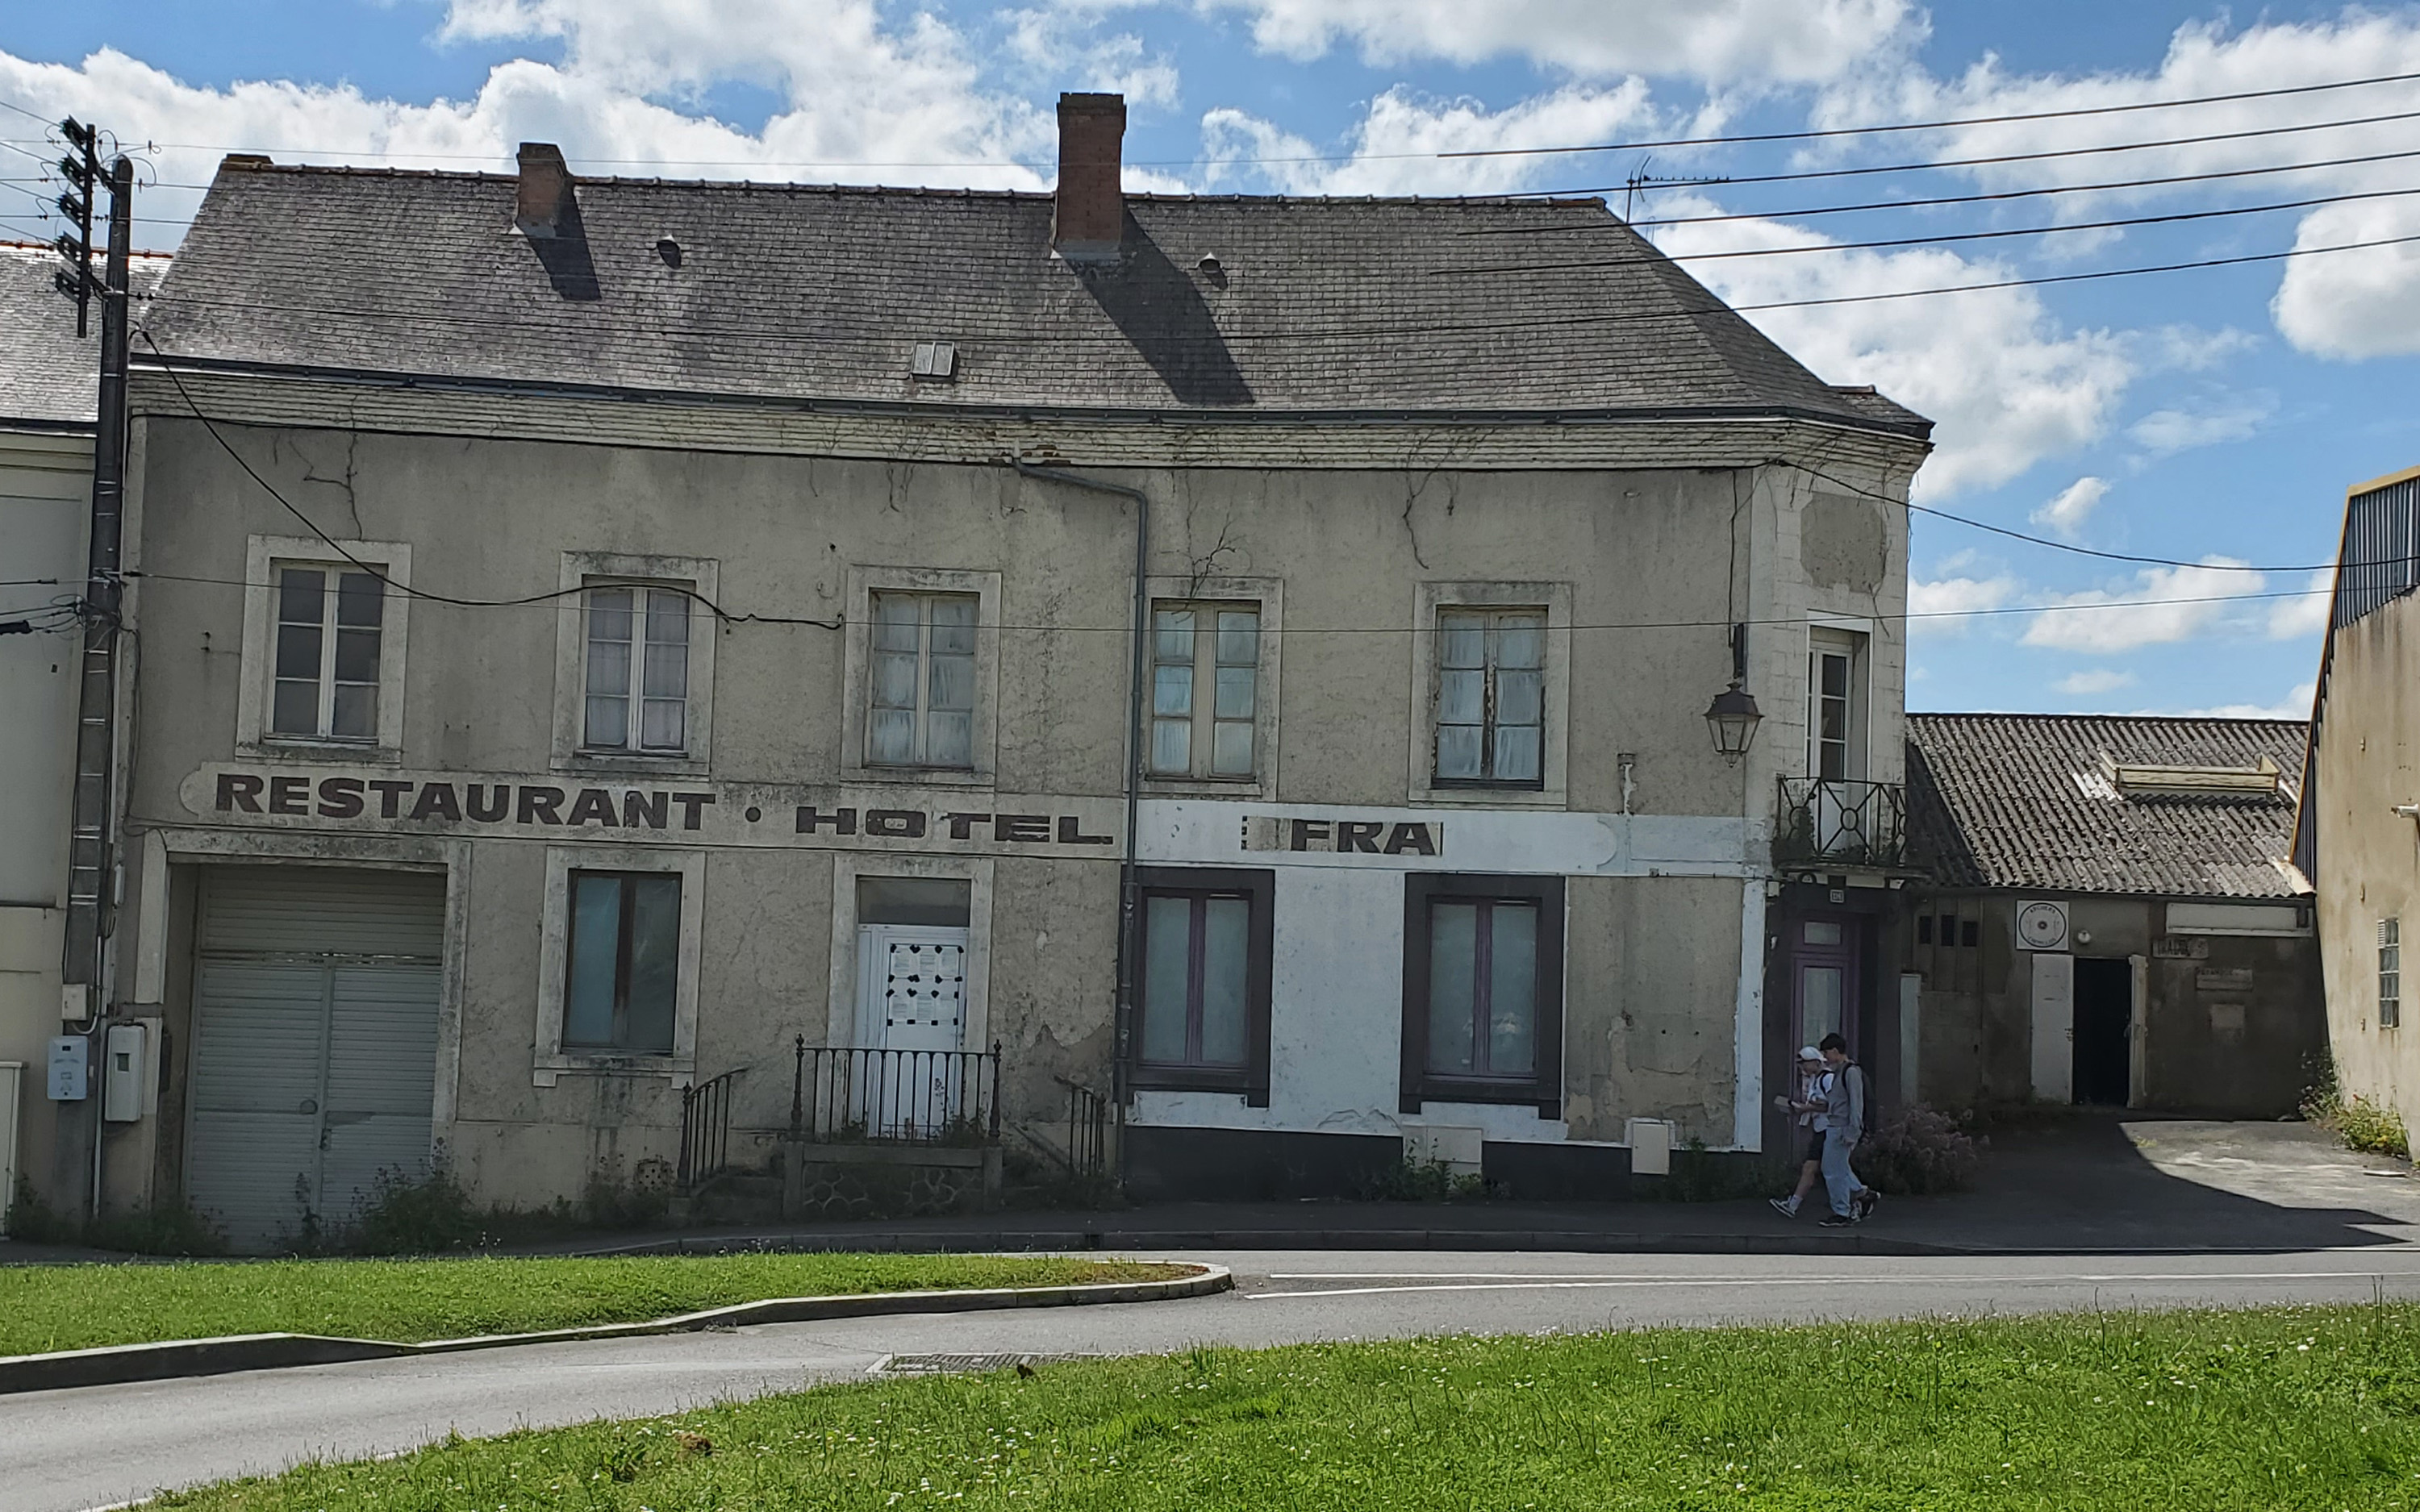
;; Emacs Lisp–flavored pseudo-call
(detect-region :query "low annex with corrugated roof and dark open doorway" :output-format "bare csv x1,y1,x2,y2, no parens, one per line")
1900,714,2328,1118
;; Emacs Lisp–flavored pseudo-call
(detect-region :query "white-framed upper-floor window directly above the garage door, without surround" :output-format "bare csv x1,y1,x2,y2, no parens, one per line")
266,561,387,745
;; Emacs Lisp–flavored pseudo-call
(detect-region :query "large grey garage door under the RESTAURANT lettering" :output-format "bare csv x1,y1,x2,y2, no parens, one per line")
186,866,445,1251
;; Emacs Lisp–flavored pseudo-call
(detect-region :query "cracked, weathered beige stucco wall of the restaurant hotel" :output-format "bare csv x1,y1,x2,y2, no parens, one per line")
121,416,1912,1200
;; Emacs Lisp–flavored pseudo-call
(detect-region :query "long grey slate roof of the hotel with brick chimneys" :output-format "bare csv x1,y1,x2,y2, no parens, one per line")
145,162,1931,443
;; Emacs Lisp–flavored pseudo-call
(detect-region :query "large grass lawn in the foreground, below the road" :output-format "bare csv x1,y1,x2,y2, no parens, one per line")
162,1304,2420,1512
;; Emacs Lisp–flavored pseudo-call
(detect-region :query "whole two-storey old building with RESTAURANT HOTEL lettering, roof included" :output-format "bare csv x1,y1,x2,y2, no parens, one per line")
90,97,1929,1243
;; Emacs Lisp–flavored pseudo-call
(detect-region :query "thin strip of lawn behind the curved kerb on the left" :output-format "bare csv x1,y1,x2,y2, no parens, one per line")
0,1256,1179,1355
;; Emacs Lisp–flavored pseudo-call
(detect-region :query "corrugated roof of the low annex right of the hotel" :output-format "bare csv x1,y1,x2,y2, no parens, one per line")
1907,714,2306,898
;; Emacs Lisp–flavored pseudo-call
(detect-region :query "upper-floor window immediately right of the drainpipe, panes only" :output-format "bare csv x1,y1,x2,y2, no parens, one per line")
1150,600,1261,779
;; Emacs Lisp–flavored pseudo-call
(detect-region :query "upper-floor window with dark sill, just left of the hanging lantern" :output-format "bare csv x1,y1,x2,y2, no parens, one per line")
1435,605,1546,786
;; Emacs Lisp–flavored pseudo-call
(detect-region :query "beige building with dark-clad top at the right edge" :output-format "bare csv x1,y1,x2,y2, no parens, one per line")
2294,467,2420,1127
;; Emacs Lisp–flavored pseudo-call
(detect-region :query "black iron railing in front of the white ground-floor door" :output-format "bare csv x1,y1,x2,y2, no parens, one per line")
789,1035,999,1144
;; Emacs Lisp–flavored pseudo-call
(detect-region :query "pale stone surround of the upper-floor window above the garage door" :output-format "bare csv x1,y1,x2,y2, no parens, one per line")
235,535,411,764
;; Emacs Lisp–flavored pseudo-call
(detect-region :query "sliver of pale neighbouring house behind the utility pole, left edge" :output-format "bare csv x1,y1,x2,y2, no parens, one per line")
0,244,167,1227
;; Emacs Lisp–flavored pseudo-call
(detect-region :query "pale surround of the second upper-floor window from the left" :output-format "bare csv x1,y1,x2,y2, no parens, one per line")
552,552,721,777
